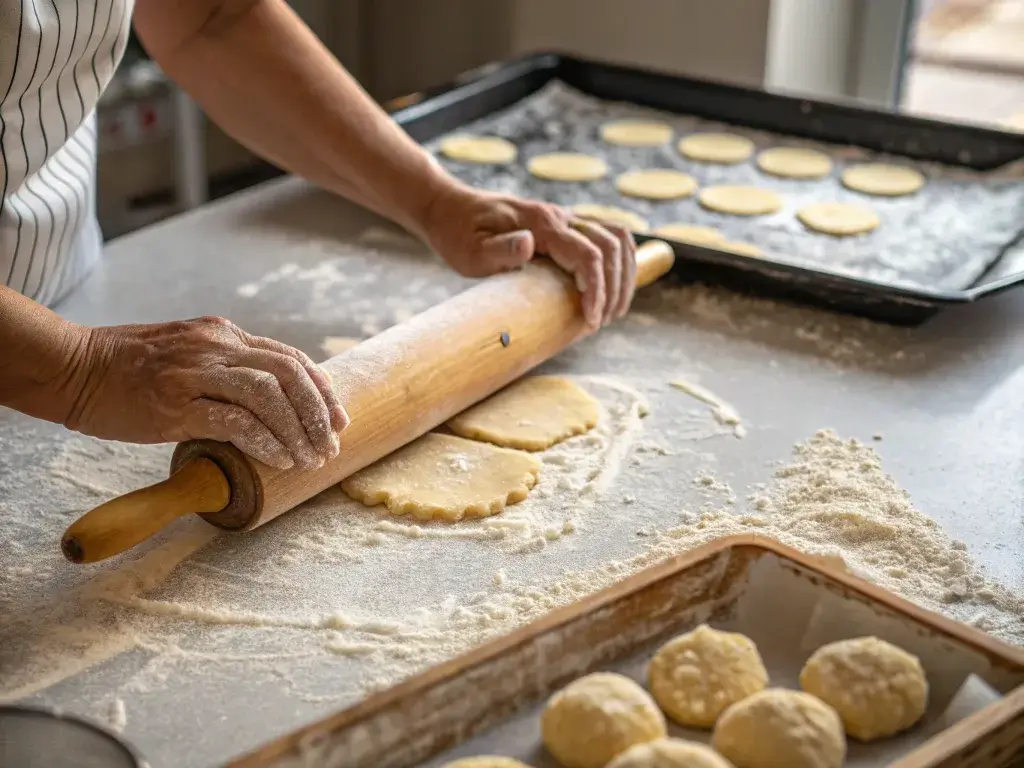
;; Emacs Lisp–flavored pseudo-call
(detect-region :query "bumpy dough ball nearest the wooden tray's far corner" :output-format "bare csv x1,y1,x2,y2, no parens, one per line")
648,625,768,728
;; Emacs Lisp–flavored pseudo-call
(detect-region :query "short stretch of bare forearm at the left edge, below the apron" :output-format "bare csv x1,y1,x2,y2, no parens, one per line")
0,286,89,424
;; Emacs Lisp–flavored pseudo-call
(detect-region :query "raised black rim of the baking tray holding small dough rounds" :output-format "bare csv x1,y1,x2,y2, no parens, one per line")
386,52,1024,326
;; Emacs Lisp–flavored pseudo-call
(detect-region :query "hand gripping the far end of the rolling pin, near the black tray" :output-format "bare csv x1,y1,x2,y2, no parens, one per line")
423,184,636,329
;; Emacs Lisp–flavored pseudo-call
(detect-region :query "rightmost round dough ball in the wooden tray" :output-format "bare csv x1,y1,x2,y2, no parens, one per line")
800,637,928,741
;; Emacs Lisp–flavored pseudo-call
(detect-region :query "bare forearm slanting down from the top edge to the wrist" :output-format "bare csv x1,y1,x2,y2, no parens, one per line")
136,0,453,237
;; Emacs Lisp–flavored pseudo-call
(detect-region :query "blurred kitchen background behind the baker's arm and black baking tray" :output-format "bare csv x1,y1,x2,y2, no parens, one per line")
98,0,1024,238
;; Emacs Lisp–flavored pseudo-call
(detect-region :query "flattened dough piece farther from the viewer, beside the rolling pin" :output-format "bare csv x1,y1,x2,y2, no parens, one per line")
449,376,600,451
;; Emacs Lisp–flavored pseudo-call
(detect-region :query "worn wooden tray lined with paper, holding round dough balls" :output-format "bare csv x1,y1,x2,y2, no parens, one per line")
228,536,1024,768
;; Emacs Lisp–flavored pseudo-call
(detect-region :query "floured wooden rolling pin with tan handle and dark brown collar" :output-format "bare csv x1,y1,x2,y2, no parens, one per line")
60,240,674,563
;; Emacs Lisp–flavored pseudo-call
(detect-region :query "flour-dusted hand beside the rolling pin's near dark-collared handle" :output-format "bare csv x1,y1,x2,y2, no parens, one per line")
66,317,348,469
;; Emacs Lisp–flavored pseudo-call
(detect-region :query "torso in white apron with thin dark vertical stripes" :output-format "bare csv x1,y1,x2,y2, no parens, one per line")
0,0,134,304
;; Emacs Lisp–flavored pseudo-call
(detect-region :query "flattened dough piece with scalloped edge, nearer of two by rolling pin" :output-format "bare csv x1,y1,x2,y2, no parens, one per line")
341,432,541,520
